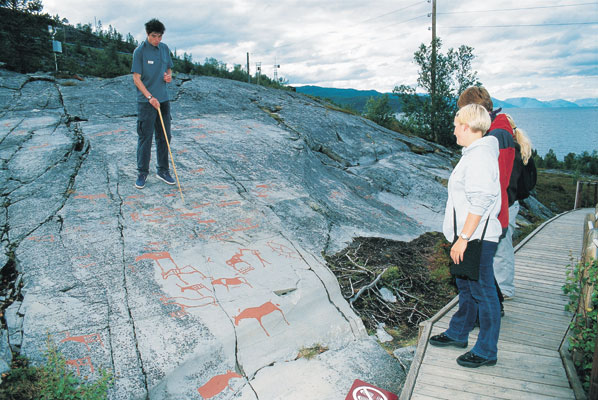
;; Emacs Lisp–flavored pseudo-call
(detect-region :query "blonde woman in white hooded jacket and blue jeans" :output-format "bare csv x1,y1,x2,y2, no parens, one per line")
430,104,502,368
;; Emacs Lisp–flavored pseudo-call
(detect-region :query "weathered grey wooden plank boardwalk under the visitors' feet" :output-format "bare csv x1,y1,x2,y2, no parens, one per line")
401,209,592,400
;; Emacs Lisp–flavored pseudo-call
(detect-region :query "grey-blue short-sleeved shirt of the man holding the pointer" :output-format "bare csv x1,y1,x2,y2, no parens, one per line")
131,40,174,103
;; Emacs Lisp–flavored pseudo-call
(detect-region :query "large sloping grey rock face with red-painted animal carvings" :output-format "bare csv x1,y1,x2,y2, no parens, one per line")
0,71,452,400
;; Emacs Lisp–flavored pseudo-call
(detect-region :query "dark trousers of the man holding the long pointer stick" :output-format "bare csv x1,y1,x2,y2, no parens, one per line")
137,101,172,176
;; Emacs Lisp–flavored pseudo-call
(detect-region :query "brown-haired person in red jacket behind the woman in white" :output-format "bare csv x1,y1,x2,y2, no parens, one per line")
457,86,521,306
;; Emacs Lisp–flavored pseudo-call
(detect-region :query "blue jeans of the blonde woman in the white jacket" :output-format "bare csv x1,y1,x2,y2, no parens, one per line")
445,240,500,360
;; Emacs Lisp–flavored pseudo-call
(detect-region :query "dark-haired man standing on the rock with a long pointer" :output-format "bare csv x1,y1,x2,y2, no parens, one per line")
131,18,175,189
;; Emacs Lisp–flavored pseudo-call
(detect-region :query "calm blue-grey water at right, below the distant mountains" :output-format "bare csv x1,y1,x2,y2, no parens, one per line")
502,107,598,161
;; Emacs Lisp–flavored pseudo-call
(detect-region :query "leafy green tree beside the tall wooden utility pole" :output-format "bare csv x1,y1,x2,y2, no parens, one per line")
393,38,480,146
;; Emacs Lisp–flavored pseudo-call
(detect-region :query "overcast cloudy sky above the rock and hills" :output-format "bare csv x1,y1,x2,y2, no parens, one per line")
42,0,598,100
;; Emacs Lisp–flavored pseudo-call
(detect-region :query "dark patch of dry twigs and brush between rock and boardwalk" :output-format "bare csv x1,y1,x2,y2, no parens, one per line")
325,232,457,347
